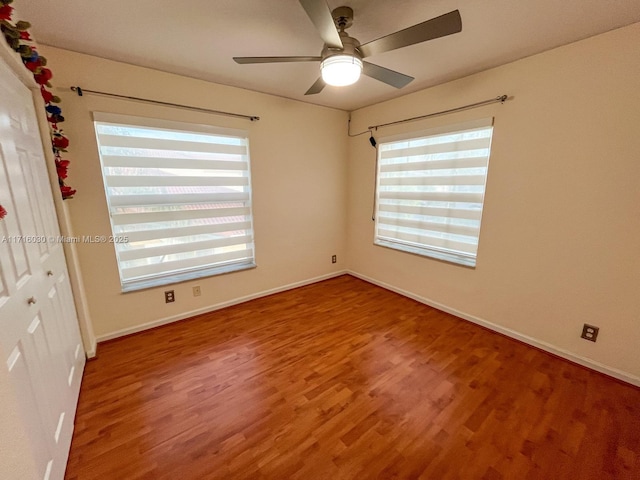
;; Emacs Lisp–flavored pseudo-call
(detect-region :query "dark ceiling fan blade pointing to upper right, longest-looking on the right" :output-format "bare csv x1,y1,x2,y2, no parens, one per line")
360,10,462,57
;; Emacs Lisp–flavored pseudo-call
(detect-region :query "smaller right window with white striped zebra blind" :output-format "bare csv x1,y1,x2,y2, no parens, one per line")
375,119,493,267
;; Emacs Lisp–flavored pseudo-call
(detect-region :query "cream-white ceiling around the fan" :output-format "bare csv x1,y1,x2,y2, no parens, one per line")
14,0,640,110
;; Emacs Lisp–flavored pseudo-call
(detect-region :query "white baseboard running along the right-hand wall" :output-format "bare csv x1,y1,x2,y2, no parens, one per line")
346,271,640,387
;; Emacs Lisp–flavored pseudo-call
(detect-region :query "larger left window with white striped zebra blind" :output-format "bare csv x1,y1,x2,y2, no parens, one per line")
94,113,255,292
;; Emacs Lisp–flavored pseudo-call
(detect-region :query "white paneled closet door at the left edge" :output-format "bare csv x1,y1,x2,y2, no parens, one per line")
0,54,85,480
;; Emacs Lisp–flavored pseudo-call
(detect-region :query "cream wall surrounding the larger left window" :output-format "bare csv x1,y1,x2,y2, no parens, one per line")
40,46,347,339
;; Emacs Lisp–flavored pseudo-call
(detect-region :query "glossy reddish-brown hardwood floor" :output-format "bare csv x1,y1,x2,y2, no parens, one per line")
66,276,640,480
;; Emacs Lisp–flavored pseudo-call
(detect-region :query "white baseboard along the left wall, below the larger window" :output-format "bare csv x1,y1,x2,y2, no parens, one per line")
94,270,348,344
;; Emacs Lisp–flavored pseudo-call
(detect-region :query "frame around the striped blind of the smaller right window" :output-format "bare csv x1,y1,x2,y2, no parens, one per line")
373,117,494,268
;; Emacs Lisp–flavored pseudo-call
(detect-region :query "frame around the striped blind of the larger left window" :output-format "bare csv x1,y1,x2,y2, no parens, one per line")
93,112,257,293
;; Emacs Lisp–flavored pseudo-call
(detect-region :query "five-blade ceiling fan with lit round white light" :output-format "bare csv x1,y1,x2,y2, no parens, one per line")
233,0,462,95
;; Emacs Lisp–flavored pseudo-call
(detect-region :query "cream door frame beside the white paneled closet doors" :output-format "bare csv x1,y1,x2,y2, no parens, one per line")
0,40,97,358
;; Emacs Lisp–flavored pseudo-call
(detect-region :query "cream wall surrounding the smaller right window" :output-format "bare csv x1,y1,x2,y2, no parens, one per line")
347,24,640,384
